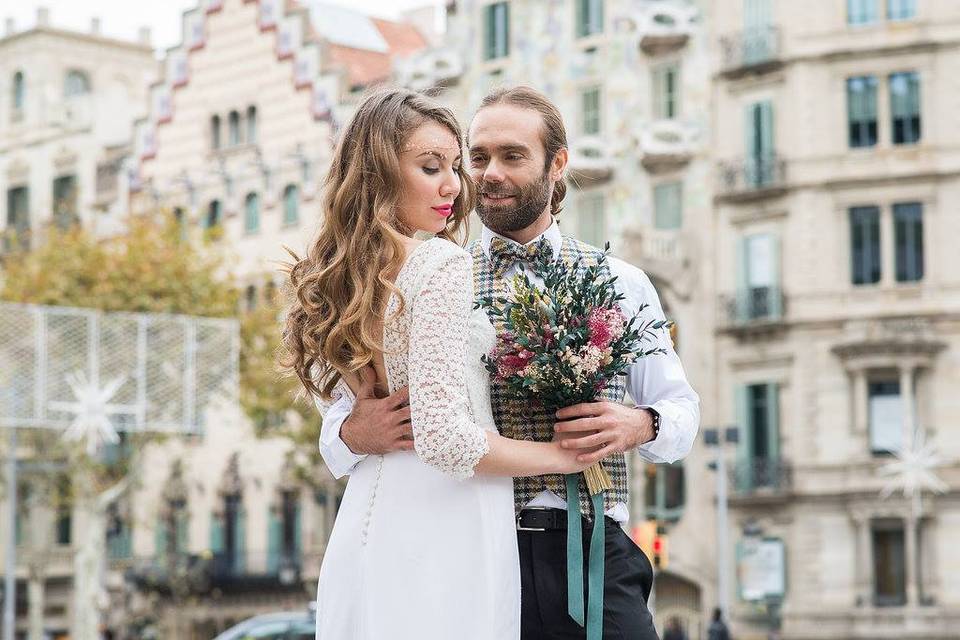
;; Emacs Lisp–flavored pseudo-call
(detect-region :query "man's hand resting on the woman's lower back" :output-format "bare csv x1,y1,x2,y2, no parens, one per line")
340,367,413,455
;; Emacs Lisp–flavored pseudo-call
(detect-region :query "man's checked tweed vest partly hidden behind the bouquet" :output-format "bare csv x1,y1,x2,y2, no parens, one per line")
470,237,629,518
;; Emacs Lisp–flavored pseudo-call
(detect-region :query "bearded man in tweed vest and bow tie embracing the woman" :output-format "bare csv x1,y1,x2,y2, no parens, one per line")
320,87,700,640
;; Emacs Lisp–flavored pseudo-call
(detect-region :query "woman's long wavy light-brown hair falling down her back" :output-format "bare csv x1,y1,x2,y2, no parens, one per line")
280,88,475,400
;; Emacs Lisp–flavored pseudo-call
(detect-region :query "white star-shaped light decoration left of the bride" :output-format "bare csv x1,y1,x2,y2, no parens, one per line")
47,371,136,456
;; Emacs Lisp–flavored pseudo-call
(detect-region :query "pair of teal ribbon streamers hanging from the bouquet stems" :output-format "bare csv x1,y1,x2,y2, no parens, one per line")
566,474,606,640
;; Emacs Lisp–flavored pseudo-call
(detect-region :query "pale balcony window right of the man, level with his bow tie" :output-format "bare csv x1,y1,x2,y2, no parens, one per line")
736,233,783,322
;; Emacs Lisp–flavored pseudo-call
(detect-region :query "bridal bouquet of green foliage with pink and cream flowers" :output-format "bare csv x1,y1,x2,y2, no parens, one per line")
476,243,671,495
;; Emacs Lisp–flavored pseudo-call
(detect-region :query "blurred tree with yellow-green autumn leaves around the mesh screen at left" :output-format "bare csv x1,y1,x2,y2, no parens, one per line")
0,214,320,640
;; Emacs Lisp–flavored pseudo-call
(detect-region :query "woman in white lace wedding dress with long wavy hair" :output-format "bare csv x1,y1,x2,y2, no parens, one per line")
283,89,583,640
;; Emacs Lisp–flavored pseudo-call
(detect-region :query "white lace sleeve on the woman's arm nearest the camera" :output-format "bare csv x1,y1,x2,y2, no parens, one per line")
407,245,489,478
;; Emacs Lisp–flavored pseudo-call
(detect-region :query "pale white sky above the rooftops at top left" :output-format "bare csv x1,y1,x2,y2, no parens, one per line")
0,0,440,49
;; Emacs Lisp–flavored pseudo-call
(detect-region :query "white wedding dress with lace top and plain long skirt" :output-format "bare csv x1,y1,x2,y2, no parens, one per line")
317,238,520,640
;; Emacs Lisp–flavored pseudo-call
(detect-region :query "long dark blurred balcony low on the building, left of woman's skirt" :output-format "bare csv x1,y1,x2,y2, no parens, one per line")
126,552,303,595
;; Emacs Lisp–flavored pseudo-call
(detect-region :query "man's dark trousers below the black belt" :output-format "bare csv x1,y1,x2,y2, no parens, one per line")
517,518,657,640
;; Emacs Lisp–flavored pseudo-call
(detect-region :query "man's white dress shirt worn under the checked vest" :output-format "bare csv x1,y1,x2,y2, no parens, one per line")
318,221,700,523
